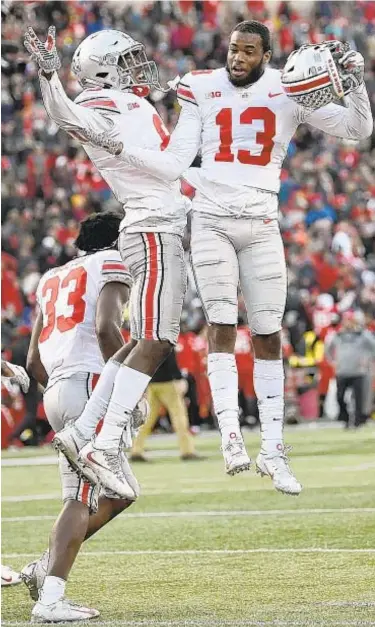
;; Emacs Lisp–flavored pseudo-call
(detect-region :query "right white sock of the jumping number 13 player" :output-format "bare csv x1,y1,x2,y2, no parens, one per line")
254,359,284,454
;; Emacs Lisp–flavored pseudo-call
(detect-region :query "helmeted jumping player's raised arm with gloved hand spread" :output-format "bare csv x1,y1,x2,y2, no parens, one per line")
24,26,111,136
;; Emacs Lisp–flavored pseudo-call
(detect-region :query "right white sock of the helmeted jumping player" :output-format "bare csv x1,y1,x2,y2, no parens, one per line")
95,366,151,449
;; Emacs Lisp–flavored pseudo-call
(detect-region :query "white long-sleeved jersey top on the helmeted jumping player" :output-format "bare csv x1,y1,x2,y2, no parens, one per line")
40,73,190,234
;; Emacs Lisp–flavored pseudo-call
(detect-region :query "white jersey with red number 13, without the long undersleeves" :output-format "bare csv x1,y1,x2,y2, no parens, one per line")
181,68,298,192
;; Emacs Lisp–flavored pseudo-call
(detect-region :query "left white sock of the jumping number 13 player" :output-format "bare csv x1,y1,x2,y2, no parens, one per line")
207,353,240,437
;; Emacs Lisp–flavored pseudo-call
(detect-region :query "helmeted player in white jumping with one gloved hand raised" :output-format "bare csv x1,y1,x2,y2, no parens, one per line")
25,27,190,498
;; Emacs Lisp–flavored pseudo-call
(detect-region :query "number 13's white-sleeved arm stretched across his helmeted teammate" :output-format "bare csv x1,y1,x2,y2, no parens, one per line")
78,79,202,181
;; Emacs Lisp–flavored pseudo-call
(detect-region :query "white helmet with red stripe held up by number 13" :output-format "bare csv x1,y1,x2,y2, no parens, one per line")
281,41,359,109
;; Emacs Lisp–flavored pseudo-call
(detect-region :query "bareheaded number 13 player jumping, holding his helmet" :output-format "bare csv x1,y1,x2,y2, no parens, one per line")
80,21,373,494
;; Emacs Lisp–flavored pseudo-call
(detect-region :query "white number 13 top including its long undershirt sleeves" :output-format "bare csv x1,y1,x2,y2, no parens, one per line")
121,67,373,218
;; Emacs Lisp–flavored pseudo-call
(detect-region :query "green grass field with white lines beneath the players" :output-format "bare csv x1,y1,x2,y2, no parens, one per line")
2,427,375,627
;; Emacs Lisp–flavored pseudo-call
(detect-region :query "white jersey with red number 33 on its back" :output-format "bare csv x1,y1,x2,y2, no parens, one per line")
36,250,132,385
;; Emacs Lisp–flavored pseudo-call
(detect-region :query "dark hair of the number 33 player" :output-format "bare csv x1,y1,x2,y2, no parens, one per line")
74,211,121,253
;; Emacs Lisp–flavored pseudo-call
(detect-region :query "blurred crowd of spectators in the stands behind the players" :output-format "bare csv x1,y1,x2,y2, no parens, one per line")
1,0,375,444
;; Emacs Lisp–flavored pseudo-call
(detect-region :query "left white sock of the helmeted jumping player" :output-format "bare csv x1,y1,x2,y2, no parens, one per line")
75,359,121,440
